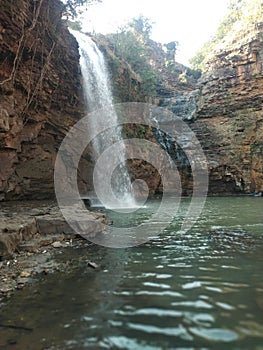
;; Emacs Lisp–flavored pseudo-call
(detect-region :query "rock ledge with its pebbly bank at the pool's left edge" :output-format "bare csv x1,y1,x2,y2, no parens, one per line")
0,201,106,302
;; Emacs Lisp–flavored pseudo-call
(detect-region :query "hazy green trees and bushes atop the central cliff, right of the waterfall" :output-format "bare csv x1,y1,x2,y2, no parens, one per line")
96,16,199,97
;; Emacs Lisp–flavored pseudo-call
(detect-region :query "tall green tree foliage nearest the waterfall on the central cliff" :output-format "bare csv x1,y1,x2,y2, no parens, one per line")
107,16,158,96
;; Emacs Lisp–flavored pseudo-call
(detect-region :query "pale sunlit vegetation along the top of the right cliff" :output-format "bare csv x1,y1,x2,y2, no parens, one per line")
190,0,263,71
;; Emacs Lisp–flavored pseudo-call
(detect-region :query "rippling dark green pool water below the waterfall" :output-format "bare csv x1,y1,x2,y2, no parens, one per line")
0,197,263,350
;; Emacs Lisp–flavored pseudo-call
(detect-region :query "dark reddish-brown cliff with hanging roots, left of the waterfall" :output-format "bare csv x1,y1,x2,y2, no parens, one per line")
0,0,83,200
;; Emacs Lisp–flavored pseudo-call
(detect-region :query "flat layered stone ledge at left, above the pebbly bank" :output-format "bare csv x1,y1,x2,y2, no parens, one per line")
0,201,108,259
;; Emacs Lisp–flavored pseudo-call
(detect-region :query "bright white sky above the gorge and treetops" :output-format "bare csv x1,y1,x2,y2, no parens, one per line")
82,0,228,65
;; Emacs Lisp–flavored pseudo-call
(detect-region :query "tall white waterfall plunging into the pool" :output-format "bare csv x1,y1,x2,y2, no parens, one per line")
71,30,136,208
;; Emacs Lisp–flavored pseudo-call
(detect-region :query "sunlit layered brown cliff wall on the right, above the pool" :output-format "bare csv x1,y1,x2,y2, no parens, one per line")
196,23,263,193
